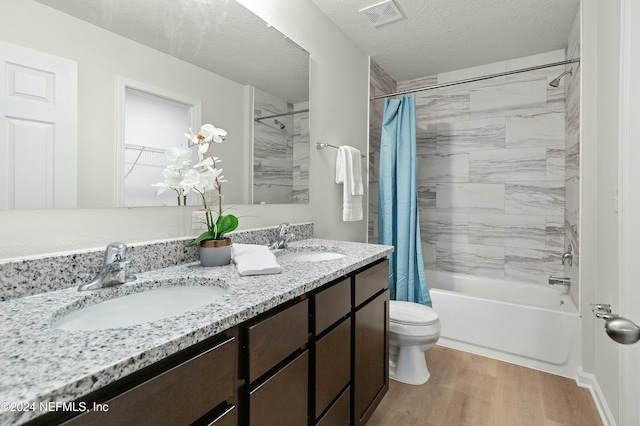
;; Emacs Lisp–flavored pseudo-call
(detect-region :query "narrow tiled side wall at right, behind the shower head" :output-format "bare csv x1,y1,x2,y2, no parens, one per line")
563,9,580,306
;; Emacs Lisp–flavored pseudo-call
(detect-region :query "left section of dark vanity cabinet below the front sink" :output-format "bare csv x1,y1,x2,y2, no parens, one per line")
56,329,238,426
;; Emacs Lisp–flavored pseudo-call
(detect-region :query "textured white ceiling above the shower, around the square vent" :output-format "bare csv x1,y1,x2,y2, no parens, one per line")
311,0,580,81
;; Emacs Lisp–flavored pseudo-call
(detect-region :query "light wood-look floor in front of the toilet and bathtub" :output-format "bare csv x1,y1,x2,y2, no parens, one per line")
367,346,602,426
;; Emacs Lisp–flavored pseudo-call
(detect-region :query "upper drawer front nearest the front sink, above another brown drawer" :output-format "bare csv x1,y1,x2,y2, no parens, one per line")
248,299,309,382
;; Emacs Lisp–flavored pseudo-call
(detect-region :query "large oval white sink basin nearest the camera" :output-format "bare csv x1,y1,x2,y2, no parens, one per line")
53,286,226,331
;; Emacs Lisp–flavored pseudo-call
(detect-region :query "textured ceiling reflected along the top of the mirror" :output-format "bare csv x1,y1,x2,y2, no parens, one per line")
37,0,309,103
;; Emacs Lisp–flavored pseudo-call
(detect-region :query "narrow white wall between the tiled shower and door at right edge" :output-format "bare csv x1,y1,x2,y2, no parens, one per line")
580,0,620,422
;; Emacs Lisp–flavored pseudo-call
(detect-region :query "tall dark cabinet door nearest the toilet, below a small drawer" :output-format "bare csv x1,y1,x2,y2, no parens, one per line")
353,289,389,425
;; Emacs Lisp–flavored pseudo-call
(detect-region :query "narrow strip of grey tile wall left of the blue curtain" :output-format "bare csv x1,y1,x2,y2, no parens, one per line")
368,60,396,244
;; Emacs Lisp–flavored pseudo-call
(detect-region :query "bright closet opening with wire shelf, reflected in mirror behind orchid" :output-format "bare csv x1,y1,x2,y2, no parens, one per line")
124,88,191,207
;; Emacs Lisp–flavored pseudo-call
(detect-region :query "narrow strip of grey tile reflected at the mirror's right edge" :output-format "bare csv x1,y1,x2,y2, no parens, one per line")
293,102,310,204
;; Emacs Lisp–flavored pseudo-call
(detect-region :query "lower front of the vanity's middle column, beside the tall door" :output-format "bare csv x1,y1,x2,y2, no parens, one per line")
315,318,351,418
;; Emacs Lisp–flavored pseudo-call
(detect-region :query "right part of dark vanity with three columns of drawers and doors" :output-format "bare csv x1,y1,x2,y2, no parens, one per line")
239,259,389,426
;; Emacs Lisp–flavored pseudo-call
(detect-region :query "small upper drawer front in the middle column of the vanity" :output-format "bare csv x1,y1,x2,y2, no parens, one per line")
314,278,351,336
